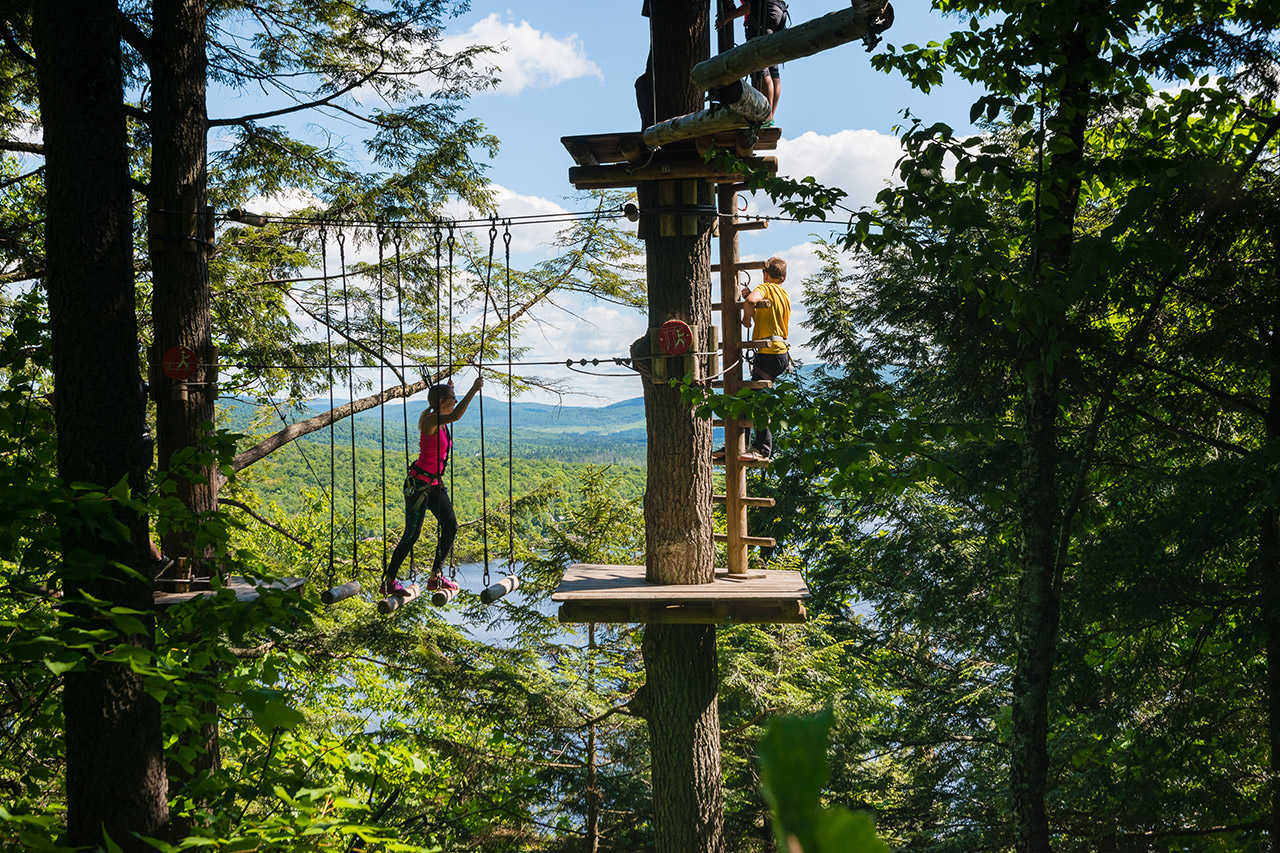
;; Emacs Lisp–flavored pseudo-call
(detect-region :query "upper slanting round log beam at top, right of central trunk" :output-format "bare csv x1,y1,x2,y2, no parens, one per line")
690,0,888,90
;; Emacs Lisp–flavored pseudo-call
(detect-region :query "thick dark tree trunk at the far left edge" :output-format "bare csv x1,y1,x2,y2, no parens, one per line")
33,0,168,850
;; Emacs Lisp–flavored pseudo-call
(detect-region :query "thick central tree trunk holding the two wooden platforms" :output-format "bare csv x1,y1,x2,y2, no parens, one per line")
640,0,723,853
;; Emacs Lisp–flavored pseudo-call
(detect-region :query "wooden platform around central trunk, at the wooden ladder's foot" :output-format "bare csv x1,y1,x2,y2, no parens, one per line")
552,562,809,624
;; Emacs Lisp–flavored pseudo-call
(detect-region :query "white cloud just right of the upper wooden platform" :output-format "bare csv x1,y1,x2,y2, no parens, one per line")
762,131,902,207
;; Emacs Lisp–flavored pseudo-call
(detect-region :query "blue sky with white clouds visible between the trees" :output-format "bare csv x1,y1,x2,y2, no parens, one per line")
222,0,977,405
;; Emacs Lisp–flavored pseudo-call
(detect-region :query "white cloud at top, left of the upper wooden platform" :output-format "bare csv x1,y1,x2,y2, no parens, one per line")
443,13,604,95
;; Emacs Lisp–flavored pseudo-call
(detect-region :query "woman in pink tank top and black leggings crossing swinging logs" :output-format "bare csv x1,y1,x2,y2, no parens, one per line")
379,377,484,596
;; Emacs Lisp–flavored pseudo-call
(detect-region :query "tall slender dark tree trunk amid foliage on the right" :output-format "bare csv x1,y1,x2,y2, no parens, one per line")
1010,8,1096,853
